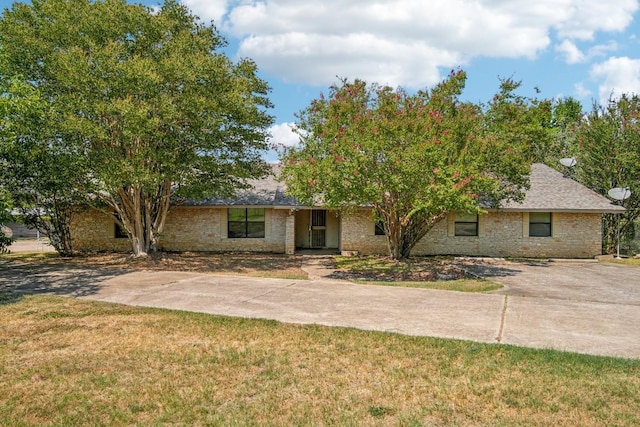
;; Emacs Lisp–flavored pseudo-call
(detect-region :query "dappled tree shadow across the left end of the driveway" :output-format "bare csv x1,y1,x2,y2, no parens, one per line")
0,260,130,302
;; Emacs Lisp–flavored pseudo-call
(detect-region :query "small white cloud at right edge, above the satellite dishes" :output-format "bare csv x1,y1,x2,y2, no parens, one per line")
591,57,640,103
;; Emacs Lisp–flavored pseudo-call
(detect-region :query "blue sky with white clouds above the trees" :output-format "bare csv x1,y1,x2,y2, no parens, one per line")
0,0,640,160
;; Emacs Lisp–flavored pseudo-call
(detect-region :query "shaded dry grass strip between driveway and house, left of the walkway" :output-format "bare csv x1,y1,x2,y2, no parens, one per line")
0,252,308,279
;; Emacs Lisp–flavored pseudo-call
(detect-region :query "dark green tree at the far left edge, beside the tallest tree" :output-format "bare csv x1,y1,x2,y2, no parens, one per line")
0,78,84,256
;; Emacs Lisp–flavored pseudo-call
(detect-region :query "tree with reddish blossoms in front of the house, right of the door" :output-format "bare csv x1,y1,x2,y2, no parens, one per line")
282,71,529,259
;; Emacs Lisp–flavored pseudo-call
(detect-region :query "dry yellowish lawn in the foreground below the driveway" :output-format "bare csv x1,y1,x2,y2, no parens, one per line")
0,293,640,426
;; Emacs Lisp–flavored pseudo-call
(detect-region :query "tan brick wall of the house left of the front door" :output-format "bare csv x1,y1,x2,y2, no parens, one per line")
72,206,288,253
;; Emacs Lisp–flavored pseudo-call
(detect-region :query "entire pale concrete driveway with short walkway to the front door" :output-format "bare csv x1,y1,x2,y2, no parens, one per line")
0,258,640,358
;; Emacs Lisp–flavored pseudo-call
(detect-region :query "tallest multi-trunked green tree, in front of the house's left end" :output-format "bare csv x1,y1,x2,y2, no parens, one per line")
0,0,272,256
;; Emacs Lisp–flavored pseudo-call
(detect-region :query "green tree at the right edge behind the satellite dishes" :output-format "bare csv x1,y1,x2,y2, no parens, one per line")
575,94,640,253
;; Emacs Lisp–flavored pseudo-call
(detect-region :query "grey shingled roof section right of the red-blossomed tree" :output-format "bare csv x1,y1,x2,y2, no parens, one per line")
502,163,624,213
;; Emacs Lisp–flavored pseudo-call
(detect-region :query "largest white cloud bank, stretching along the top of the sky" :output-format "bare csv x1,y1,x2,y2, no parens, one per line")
184,0,638,88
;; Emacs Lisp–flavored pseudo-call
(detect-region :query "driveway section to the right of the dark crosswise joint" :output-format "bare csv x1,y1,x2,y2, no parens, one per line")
456,261,640,358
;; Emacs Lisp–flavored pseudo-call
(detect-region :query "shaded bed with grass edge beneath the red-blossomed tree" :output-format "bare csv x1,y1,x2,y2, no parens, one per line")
335,256,502,292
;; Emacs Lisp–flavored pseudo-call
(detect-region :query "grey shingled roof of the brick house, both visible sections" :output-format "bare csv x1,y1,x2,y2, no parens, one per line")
188,163,624,213
